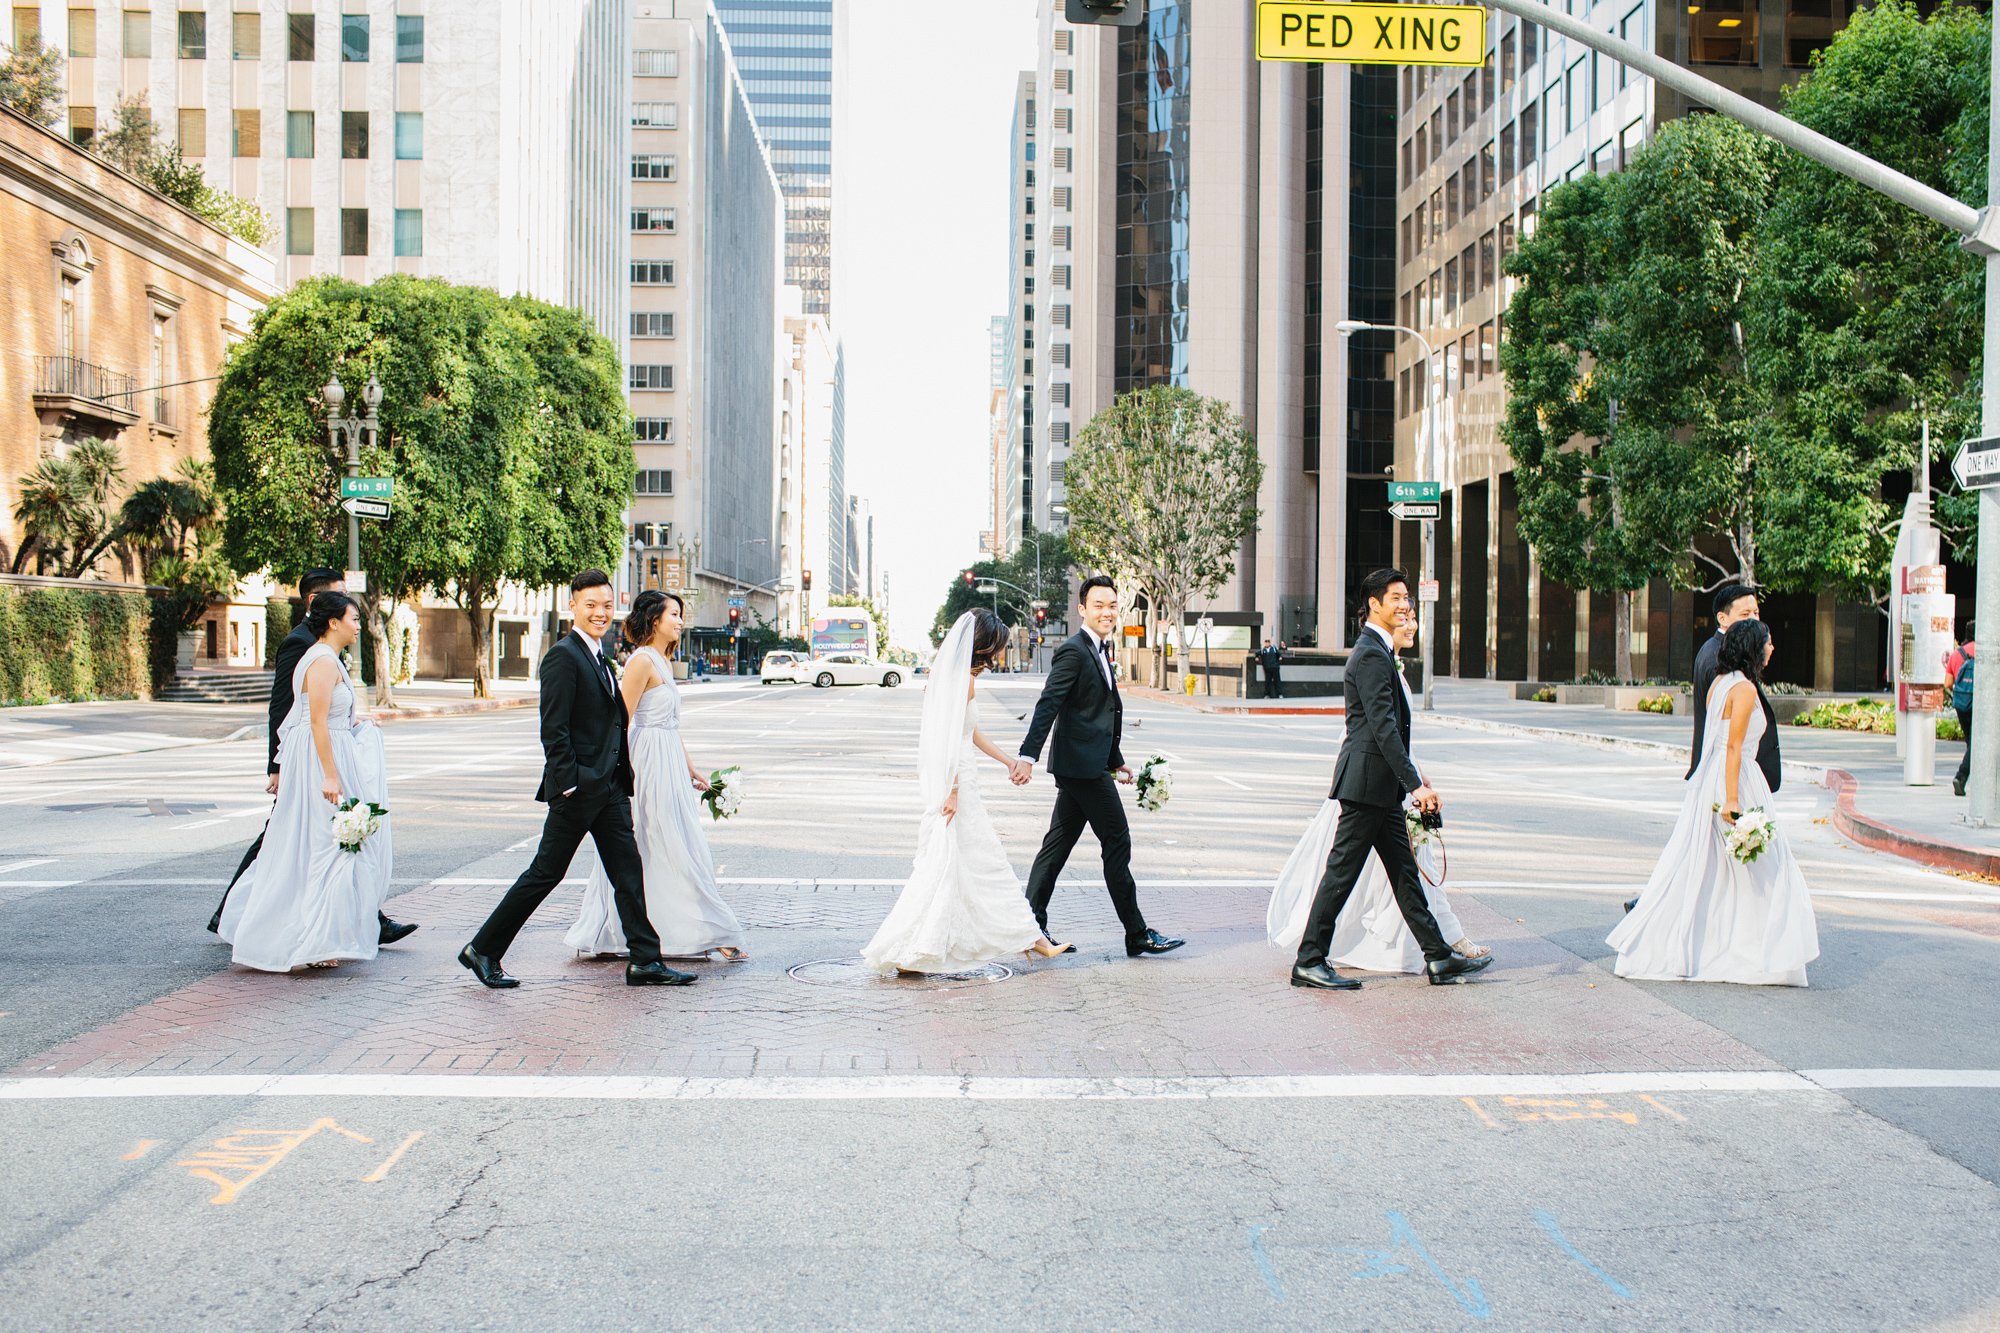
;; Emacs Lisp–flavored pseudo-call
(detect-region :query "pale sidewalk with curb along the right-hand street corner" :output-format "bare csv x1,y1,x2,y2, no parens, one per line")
1430,681,2000,879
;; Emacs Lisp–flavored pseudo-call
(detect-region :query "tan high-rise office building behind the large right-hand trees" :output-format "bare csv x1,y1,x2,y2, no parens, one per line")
1408,0,1880,689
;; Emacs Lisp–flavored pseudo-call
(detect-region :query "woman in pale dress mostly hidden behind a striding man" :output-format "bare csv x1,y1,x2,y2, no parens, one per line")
1264,616,1492,973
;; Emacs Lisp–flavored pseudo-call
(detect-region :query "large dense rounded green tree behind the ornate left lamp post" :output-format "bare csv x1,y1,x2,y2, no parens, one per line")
208,274,632,705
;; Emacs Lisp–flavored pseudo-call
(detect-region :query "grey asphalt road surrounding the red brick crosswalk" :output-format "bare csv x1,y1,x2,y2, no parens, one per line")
0,679,2000,1333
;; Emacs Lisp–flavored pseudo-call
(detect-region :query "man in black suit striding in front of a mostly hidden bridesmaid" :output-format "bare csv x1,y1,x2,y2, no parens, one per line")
1292,568,1492,991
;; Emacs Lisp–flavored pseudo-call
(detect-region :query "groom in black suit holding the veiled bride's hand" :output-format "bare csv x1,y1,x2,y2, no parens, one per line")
1014,574,1186,959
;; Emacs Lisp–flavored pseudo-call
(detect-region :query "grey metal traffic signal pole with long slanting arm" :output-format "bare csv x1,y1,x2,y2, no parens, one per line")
1486,0,2000,827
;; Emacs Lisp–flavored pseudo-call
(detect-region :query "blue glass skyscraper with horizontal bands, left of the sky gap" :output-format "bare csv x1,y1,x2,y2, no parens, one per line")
716,0,842,314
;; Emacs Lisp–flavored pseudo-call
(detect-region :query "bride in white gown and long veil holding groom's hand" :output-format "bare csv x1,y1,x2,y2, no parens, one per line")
862,608,1074,973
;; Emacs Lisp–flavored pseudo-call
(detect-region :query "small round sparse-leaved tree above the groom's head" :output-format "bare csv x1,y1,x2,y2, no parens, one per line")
1064,386,1264,685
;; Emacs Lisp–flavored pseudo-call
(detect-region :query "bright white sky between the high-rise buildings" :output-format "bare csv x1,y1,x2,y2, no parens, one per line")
834,0,1034,648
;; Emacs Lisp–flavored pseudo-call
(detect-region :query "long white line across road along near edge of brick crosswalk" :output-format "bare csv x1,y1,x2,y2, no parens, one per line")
0,1069,1824,1101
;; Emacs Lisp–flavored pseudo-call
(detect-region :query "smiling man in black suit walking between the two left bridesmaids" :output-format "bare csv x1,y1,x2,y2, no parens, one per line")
458,568,694,989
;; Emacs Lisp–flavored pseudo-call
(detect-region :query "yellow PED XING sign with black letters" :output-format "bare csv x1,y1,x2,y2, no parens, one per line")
1256,0,1486,66
